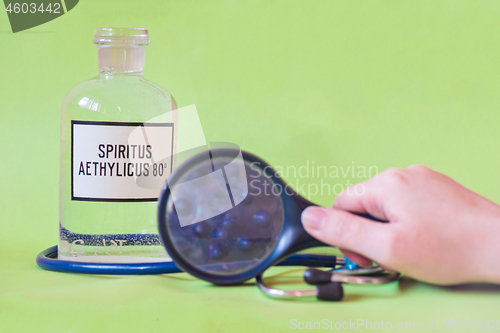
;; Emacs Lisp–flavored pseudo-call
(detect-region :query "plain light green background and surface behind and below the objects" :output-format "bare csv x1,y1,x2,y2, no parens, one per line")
0,0,500,332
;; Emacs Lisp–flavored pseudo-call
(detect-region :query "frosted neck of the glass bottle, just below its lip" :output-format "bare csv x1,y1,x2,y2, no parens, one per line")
97,44,146,76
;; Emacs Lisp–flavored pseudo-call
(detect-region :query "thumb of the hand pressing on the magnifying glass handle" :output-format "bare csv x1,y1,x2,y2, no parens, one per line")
301,206,391,263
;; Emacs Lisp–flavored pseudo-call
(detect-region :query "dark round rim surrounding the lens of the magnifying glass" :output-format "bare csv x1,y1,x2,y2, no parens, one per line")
158,149,305,285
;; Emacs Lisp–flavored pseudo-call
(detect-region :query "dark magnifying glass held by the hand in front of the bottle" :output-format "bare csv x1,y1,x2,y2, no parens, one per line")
158,148,382,285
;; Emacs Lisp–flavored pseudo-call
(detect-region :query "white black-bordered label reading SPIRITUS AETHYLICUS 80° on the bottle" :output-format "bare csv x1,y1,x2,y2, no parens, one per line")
71,120,174,201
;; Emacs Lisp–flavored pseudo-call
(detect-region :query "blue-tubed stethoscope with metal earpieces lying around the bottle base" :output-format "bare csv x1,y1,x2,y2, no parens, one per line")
36,246,401,301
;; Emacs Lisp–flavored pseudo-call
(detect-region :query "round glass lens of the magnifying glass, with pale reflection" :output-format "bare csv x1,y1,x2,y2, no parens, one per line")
166,155,284,276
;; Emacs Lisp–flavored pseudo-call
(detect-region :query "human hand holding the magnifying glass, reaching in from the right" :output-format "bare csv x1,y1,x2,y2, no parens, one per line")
302,165,500,285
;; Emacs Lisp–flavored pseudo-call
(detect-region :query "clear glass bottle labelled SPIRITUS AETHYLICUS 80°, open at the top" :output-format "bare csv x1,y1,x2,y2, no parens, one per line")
58,28,177,262
